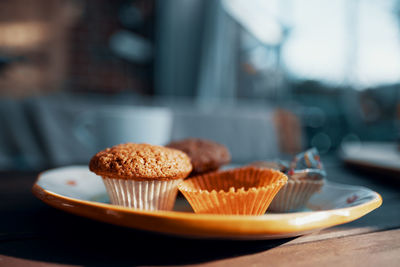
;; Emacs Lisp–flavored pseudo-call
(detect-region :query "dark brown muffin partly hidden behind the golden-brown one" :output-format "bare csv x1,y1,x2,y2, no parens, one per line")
167,138,231,176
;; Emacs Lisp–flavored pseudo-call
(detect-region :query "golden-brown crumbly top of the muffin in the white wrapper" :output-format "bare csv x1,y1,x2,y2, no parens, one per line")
89,143,192,180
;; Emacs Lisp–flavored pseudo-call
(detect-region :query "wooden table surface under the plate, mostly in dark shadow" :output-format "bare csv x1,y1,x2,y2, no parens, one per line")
0,159,400,267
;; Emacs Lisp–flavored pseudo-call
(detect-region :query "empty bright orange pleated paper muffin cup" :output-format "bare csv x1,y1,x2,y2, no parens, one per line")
178,167,287,215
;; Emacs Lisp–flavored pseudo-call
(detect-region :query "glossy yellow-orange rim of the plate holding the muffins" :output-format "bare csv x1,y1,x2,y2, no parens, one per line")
32,165,382,239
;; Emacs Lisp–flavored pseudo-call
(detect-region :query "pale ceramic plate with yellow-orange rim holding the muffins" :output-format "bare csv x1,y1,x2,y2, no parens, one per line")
33,166,382,239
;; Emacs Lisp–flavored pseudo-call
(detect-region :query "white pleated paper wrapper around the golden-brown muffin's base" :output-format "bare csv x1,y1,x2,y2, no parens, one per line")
103,177,182,210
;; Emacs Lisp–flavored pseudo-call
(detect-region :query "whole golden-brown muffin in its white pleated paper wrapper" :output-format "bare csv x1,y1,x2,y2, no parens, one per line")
89,143,192,213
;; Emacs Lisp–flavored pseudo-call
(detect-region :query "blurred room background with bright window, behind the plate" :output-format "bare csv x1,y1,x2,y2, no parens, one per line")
0,0,400,170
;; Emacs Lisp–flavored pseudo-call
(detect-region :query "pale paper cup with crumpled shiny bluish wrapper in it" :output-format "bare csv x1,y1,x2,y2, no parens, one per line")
251,148,326,212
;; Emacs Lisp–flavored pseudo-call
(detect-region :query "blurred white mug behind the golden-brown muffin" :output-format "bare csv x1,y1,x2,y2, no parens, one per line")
74,106,173,151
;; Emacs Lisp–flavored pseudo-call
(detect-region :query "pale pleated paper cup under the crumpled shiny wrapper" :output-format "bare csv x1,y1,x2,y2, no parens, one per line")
269,180,324,212
